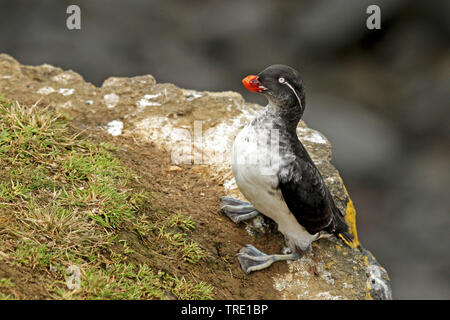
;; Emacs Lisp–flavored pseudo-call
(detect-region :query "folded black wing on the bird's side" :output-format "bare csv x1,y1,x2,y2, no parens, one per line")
278,142,352,241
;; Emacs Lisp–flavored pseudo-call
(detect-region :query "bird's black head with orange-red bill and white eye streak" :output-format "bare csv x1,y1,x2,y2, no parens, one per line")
242,64,305,115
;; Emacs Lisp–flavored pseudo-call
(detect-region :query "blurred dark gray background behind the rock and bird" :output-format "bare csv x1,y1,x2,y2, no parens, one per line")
0,0,450,299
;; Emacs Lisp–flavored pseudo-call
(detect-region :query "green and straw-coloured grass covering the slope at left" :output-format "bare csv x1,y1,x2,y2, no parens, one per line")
0,96,212,299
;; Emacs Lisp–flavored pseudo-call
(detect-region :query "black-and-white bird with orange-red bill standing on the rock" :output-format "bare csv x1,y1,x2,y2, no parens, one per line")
221,64,354,274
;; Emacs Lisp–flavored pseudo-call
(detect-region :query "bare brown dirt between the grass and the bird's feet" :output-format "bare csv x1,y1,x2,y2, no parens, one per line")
85,128,287,299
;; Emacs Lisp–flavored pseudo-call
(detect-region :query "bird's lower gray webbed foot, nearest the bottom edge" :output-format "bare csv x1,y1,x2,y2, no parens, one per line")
237,244,299,274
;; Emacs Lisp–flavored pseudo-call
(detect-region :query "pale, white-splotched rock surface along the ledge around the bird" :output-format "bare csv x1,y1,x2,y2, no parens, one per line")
0,54,392,299
